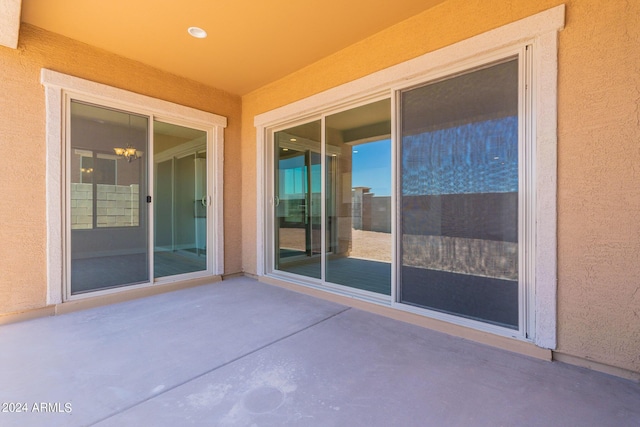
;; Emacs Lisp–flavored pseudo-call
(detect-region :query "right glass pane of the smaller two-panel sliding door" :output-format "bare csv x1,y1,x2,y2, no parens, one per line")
153,121,209,278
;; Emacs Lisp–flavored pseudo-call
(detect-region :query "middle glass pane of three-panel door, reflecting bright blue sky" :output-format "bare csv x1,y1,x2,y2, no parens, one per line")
325,99,392,295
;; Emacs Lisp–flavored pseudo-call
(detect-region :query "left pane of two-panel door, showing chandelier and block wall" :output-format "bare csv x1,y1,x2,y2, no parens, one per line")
67,101,149,295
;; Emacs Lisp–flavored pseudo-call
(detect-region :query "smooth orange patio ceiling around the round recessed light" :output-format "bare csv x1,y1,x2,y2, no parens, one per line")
22,0,445,95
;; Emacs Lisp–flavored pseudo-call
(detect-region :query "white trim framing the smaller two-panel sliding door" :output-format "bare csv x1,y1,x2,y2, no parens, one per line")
40,68,227,305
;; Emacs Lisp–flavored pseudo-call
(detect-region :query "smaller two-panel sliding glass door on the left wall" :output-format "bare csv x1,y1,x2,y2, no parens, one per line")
66,100,212,297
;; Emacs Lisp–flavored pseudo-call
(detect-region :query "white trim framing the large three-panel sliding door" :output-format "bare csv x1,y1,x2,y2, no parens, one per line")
254,5,565,349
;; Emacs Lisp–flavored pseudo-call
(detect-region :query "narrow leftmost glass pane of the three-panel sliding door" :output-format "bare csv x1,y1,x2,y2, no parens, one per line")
274,121,322,279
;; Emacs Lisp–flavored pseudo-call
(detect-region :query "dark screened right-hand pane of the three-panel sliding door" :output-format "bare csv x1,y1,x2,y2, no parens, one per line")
400,59,518,329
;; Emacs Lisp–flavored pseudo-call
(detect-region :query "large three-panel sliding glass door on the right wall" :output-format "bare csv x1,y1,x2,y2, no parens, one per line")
269,56,531,334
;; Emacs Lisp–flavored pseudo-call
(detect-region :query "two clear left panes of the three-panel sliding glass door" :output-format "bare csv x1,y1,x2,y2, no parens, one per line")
272,99,392,295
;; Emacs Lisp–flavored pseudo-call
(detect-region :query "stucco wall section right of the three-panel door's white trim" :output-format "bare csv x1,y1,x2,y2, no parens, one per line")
558,0,640,372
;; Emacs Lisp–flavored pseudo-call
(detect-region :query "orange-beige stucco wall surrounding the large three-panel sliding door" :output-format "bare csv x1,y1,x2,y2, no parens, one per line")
242,0,640,372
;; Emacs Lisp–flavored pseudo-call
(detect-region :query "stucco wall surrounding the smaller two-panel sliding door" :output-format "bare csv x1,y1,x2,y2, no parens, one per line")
0,24,241,315
